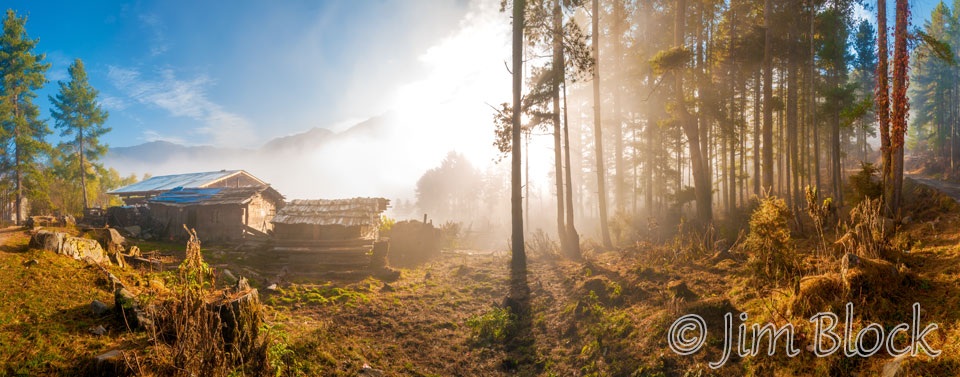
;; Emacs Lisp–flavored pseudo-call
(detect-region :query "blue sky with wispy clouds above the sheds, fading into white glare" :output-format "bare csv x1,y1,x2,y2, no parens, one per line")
4,0,468,146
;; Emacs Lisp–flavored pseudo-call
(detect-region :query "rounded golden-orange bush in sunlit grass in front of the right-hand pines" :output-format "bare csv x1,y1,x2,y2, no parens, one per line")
744,197,797,281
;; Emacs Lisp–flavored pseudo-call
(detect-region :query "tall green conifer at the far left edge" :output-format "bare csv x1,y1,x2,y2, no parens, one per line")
0,10,50,224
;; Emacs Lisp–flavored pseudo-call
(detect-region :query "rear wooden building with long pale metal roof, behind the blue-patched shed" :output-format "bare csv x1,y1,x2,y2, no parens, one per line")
108,170,268,205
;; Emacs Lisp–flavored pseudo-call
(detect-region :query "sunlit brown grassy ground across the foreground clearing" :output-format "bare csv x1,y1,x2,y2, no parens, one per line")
0,178,960,376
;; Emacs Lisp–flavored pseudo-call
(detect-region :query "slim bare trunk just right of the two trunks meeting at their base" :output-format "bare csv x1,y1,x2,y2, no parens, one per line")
592,0,613,249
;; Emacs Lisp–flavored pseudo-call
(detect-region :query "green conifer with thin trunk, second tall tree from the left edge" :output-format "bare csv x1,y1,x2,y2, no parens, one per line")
50,59,110,209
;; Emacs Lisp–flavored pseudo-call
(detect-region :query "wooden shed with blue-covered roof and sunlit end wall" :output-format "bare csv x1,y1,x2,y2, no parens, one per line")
148,186,283,242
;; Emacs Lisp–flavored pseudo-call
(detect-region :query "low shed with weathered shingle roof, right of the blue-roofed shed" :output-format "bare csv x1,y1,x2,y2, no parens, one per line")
272,198,390,240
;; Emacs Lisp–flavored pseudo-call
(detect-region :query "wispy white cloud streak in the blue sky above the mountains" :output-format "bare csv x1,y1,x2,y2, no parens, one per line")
107,66,256,146
